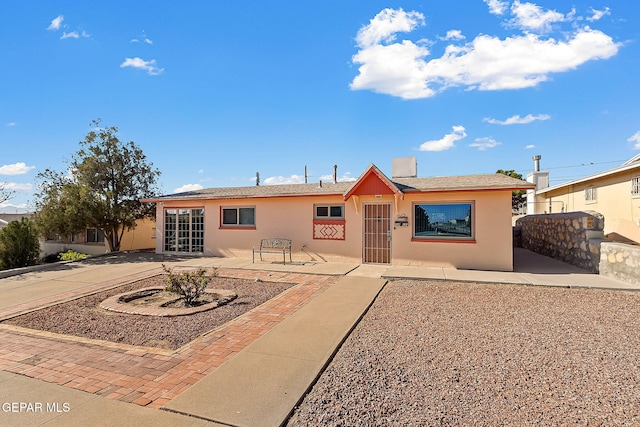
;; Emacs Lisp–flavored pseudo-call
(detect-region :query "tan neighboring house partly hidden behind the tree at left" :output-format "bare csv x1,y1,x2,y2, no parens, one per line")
40,219,156,255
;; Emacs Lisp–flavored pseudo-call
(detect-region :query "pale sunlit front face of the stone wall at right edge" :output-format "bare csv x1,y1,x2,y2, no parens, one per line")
600,242,640,285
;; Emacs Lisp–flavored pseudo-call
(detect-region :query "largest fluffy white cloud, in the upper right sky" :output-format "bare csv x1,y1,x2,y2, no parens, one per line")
350,6,618,99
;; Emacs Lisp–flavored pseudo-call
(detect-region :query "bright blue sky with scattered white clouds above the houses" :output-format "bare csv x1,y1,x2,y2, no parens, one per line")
0,0,640,212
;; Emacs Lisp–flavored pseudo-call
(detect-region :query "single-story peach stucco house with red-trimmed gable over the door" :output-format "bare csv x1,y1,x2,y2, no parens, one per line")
144,157,533,271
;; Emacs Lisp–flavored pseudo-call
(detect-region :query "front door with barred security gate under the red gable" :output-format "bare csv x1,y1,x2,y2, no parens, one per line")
362,203,391,264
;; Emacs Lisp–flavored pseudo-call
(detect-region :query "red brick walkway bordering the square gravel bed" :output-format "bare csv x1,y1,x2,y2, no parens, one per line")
0,268,339,408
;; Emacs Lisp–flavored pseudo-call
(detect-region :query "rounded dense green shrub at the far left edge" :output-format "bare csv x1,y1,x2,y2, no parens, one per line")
0,218,40,270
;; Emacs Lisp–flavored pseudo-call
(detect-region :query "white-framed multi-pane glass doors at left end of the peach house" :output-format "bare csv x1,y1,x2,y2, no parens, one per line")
164,208,204,252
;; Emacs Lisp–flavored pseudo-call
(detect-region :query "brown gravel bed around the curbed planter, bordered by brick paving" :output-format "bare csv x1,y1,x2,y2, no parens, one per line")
4,276,294,349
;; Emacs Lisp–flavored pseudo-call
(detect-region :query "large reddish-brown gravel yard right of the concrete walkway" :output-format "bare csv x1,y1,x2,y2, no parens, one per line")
289,280,640,426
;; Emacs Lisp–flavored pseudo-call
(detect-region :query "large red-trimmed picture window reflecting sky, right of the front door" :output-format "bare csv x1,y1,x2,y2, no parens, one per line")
413,202,474,240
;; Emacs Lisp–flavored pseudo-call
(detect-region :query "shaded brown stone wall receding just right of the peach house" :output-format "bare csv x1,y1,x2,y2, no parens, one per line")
514,211,604,273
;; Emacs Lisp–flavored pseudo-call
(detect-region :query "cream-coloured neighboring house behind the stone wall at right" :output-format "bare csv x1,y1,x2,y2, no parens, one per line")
528,154,640,243
